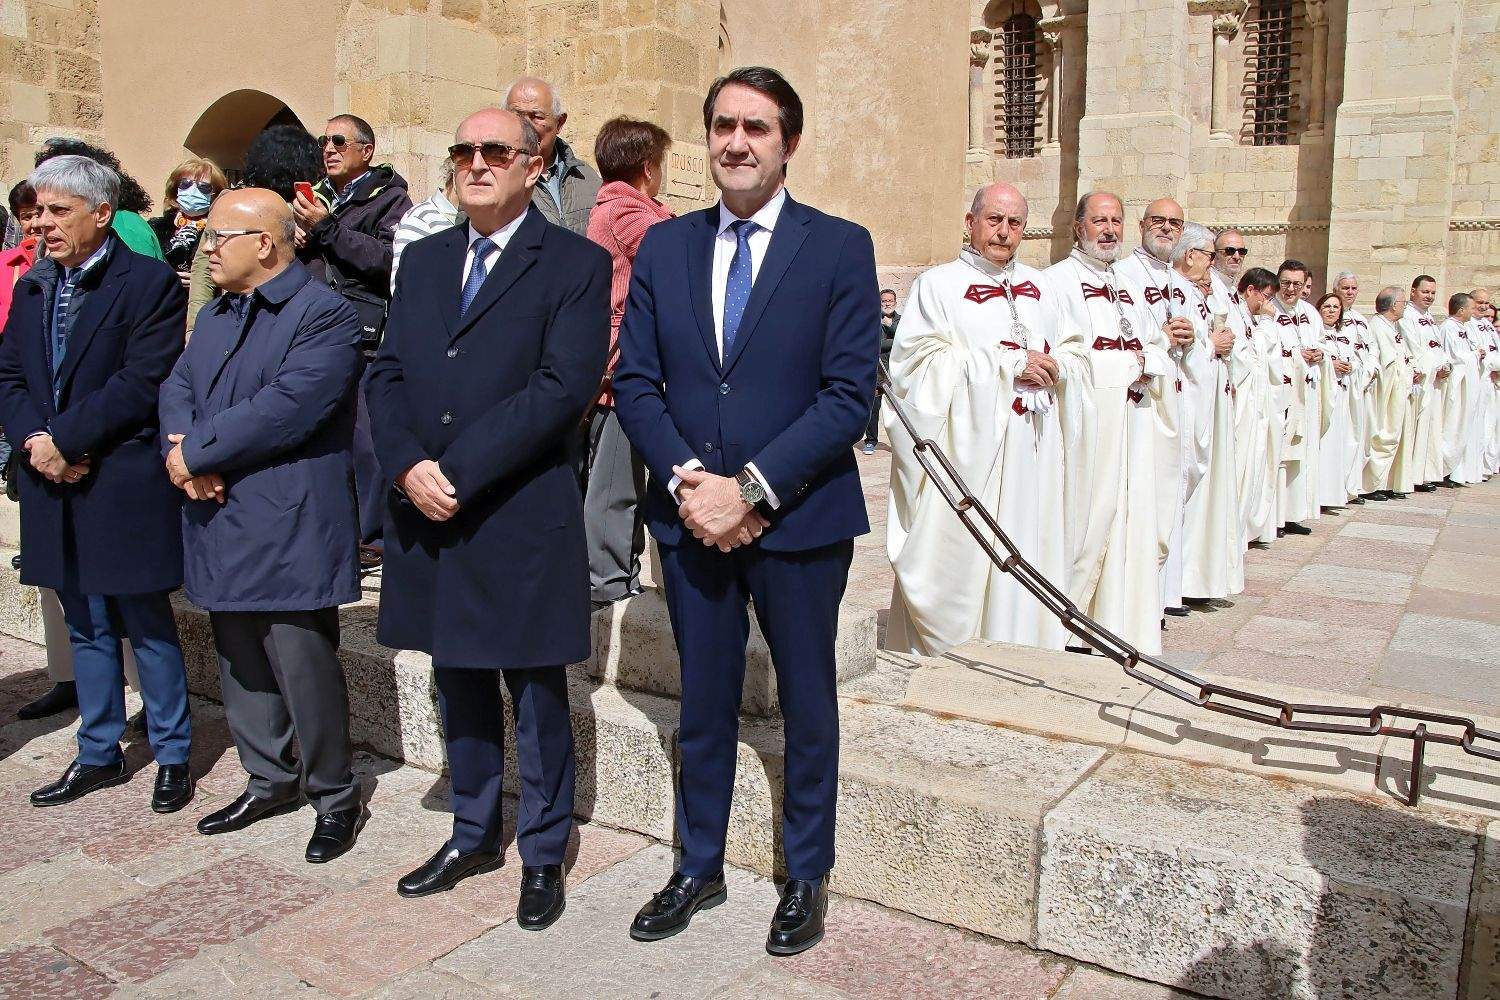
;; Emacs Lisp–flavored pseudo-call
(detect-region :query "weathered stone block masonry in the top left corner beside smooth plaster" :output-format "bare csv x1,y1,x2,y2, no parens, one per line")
0,0,104,183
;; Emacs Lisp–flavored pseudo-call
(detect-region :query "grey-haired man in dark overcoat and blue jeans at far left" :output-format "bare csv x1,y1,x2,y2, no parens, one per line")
0,156,194,813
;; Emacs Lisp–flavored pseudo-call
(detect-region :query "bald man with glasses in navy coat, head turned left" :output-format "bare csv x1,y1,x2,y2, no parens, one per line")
161,187,363,864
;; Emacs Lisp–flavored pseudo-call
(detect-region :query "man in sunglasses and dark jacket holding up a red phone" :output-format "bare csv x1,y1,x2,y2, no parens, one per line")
293,114,411,570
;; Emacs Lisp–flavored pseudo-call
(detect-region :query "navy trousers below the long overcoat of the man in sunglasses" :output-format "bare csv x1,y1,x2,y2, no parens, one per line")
432,667,575,865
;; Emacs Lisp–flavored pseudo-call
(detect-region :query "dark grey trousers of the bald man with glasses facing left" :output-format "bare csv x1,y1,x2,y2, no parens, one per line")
209,607,360,816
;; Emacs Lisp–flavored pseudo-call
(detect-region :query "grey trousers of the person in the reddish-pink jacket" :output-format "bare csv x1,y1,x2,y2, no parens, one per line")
584,406,647,601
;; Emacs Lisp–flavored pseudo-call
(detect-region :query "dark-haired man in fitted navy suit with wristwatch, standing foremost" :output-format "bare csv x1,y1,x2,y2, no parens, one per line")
615,67,881,955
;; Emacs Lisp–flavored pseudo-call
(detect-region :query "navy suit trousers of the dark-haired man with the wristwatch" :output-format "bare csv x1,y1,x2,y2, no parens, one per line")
662,541,854,880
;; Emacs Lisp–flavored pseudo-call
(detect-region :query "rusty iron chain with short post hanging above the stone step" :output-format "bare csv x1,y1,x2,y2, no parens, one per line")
876,364,1500,805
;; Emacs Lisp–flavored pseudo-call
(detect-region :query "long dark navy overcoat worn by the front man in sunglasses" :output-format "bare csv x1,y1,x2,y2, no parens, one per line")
366,208,611,669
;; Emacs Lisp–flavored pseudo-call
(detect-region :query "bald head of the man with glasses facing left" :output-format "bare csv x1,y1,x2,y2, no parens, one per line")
206,187,297,292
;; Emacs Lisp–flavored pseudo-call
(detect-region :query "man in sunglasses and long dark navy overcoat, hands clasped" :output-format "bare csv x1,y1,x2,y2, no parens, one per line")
366,108,611,930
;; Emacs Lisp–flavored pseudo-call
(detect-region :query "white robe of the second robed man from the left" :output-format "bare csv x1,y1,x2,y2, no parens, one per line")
1043,250,1176,654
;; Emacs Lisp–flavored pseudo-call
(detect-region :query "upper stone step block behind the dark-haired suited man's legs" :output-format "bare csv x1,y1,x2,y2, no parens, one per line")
585,591,876,717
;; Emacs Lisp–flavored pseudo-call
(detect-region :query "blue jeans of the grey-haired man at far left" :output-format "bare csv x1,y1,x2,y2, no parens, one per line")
57,591,192,766
